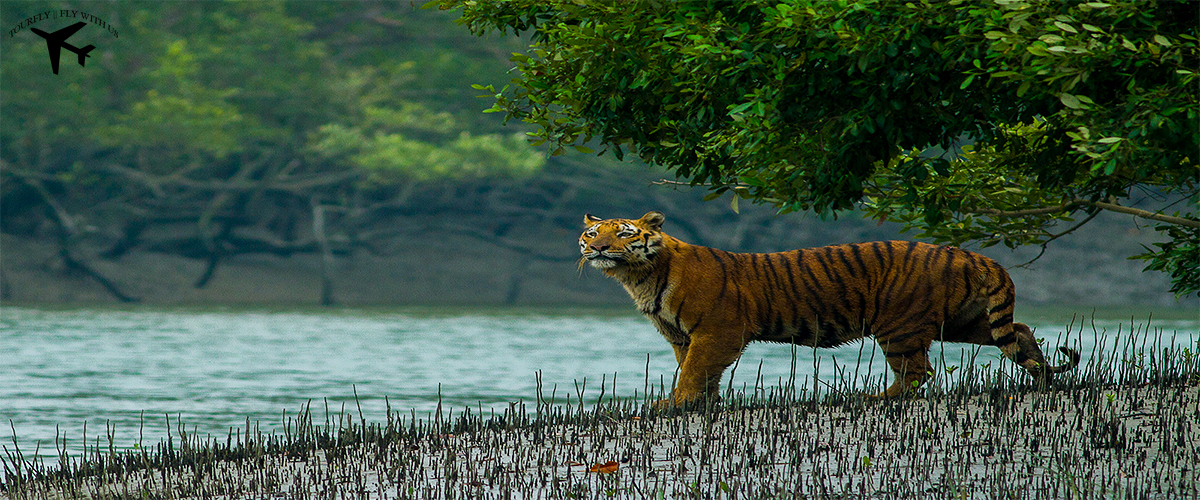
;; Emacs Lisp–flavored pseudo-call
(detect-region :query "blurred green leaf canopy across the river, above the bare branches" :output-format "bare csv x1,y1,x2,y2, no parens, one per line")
0,2,542,185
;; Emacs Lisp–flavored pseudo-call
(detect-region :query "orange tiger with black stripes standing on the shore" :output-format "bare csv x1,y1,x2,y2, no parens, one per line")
578,211,1080,405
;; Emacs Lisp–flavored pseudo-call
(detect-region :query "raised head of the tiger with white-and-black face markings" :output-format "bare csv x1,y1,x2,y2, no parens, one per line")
580,212,666,271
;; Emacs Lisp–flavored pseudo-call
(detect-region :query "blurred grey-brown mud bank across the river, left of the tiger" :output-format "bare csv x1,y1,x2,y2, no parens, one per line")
0,235,626,306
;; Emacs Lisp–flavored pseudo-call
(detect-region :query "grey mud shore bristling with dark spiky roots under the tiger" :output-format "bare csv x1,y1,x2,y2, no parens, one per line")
0,318,1200,499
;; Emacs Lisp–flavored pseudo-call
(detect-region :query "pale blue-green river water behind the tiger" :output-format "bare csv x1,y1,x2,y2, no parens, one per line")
0,307,1200,465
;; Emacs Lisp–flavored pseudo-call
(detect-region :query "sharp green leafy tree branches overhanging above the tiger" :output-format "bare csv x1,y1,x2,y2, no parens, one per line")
433,0,1200,295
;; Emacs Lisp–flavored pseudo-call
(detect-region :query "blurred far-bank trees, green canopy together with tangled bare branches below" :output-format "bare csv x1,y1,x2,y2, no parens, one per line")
0,1,545,268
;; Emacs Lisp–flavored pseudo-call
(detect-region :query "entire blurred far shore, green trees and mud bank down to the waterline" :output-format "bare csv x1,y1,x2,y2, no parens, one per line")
0,1,1200,311
